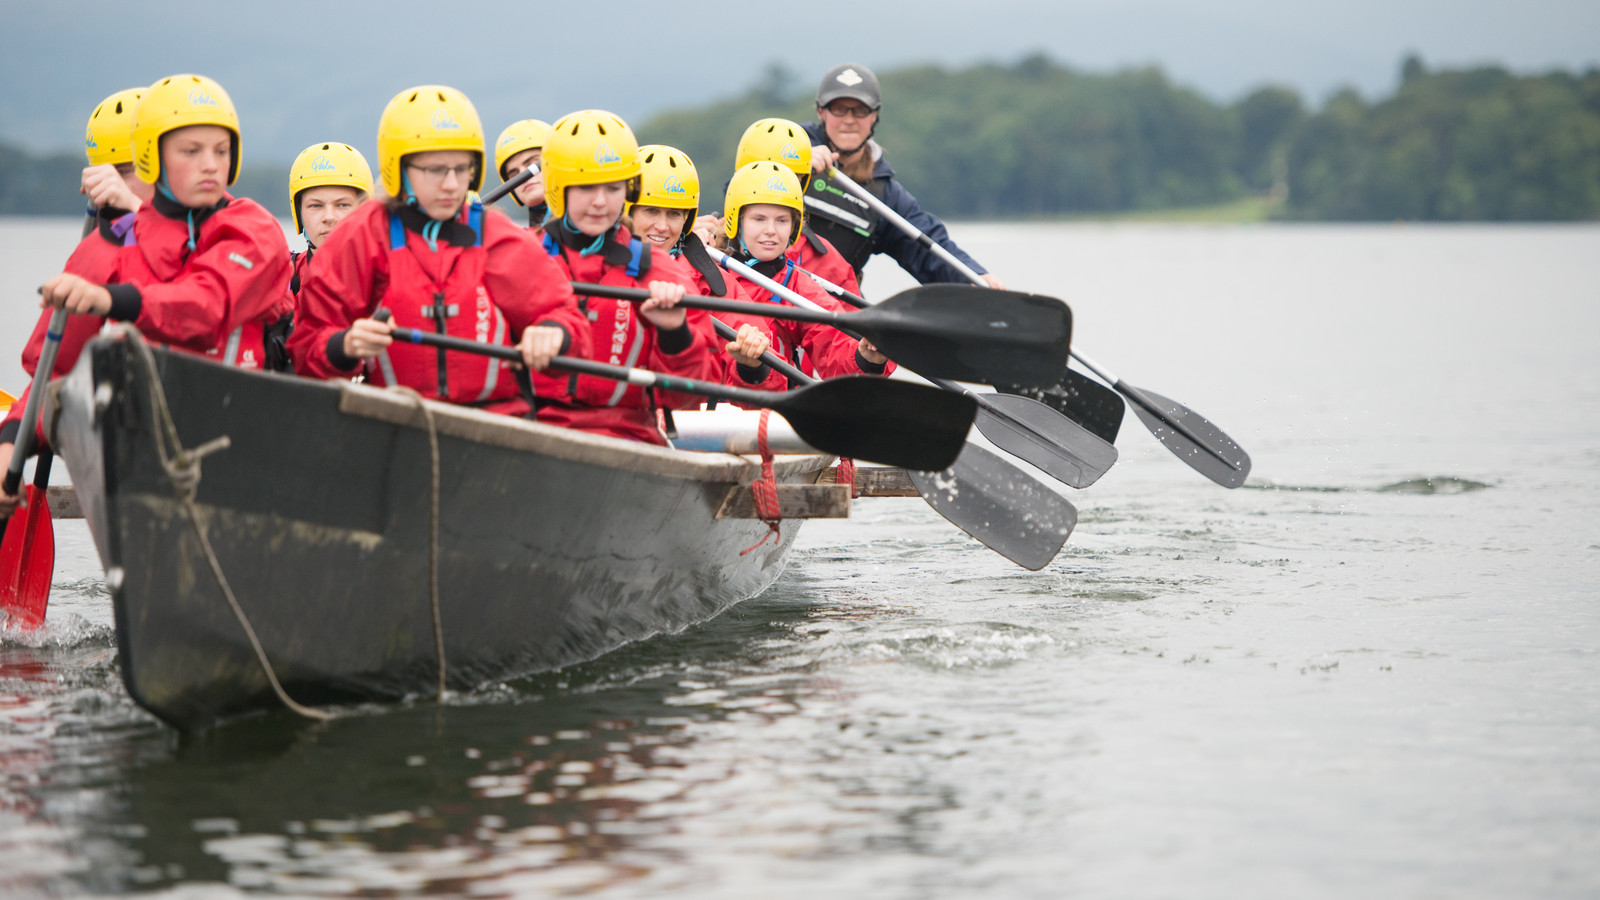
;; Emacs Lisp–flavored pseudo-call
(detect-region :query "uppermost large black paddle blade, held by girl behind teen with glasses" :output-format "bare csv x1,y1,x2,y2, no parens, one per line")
842,285,1072,384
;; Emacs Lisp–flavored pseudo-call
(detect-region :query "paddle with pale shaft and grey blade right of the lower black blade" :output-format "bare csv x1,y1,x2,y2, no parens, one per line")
718,253,1117,487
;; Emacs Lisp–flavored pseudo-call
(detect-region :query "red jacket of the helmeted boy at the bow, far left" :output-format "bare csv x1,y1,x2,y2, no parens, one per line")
109,194,294,368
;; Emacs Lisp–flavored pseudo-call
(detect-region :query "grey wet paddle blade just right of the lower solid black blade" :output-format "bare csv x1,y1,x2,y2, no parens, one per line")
978,394,1117,487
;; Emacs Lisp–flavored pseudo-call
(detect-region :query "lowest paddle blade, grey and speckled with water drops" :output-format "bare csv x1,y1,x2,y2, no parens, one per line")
910,444,1078,572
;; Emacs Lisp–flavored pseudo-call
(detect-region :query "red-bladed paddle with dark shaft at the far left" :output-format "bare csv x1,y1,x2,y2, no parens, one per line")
0,309,67,628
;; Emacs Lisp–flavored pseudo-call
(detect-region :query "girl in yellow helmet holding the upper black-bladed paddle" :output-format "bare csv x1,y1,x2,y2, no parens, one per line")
534,109,718,445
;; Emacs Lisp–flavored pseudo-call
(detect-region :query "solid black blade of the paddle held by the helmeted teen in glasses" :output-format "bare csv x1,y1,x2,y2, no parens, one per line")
771,376,978,471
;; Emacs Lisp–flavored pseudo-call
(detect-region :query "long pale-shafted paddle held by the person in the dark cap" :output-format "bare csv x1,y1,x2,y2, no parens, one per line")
827,168,1250,487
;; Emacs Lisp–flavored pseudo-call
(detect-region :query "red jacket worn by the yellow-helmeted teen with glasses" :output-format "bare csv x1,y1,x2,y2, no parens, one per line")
288,202,589,415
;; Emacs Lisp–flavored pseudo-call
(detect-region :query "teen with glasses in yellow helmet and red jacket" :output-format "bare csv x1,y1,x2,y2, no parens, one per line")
290,85,589,415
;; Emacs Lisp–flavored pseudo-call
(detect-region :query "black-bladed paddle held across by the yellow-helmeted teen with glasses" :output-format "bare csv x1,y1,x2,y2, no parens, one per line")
384,328,974,469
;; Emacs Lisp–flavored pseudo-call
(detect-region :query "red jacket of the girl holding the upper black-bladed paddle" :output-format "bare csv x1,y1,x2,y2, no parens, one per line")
533,221,720,445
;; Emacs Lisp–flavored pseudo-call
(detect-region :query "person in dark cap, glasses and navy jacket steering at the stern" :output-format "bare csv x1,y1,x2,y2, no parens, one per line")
805,62,1005,288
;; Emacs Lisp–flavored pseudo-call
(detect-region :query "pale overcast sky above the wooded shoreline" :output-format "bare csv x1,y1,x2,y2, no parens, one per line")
0,0,1600,165
